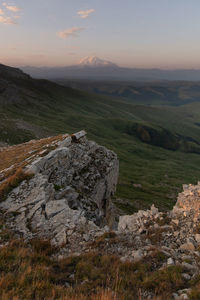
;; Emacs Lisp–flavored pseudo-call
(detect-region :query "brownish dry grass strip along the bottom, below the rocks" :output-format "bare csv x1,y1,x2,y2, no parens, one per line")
0,224,188,300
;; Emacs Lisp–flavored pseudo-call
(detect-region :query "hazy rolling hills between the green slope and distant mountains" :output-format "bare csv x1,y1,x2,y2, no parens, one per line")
55,78,200,106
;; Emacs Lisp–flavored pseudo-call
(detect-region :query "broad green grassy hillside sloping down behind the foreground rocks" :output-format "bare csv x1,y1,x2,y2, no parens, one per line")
0,65,200,212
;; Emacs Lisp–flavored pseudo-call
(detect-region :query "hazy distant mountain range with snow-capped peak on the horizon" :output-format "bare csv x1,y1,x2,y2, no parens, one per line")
21,56,200,81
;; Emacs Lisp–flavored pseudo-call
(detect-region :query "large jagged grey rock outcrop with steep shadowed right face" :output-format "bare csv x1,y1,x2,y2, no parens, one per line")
0,131,118,246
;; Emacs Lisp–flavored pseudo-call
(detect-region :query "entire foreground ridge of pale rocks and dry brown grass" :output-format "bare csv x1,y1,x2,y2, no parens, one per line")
0,130,200,300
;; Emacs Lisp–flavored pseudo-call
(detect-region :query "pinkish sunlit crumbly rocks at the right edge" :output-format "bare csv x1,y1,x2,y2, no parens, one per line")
114,183,200,299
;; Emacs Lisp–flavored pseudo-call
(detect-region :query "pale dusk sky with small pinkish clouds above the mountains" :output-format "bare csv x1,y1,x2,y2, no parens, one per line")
0,0,200,69
